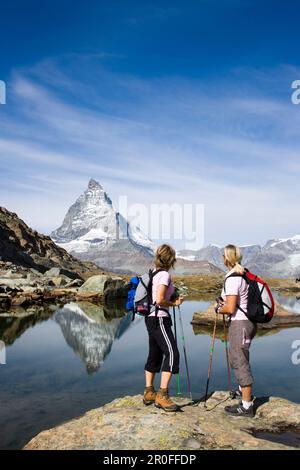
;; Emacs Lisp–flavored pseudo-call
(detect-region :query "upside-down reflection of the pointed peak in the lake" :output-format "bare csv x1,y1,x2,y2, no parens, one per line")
55,302,131,374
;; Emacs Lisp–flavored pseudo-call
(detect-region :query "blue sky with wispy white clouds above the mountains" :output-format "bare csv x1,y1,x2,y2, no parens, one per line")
0,0,300,248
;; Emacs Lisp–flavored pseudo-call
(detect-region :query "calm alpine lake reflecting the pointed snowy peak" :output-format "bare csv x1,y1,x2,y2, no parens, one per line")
0,295,300,449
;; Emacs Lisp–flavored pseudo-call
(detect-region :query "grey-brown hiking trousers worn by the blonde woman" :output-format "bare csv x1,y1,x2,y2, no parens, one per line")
229,320,257,387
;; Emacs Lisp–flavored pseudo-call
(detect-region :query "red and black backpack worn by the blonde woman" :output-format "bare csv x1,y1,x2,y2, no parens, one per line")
224,269,275,323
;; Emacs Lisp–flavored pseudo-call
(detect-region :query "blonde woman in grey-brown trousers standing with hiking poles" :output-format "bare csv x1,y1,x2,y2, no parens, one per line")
216,245,256,417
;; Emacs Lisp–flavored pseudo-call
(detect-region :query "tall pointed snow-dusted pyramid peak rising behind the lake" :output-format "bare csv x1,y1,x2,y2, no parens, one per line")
51,179,153,272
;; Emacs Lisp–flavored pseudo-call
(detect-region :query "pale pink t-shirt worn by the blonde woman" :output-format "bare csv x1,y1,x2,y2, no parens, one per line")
221,270,249,321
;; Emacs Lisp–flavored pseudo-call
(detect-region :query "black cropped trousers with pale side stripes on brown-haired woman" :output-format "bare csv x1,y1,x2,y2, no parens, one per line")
145,316,179,374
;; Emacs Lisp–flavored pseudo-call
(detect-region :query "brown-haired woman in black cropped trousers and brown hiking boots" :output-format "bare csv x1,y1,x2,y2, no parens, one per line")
143,245,183,411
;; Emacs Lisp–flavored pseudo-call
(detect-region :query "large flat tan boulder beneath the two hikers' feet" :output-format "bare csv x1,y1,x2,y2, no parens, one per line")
24,392,300,451
